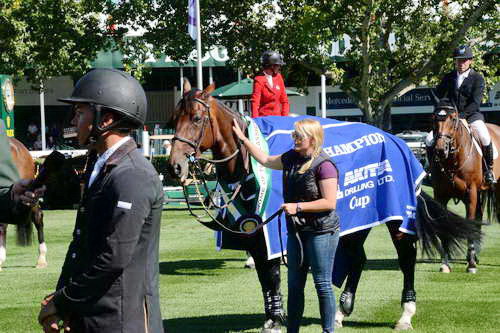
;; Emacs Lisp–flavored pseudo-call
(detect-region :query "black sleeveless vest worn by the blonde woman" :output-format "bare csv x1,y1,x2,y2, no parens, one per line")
281,149,339,233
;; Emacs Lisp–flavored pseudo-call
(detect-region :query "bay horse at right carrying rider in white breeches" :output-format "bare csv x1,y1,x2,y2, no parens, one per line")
429,100,500,273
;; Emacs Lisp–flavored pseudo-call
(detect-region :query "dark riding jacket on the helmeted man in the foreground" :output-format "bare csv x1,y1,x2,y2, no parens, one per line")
54,140,163,333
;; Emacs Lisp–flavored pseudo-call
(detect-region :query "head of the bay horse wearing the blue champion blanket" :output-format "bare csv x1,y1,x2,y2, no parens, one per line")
168,80,216,183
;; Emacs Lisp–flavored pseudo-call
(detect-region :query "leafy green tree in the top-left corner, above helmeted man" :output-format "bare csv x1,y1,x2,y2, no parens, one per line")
0,0,110,84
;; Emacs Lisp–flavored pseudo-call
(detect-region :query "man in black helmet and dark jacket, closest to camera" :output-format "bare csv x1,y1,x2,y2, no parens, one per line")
39,69,163,333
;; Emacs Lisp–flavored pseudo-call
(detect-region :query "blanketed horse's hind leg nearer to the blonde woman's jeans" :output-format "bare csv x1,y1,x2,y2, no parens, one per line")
335,229,371,327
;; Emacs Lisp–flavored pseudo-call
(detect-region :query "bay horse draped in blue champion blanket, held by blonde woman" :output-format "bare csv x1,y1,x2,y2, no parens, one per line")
168,80,479,332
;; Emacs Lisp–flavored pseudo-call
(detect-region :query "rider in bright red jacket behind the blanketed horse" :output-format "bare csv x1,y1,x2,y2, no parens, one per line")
251,51,290,118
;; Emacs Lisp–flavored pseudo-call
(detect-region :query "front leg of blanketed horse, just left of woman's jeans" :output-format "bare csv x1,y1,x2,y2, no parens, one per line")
249,234,285,333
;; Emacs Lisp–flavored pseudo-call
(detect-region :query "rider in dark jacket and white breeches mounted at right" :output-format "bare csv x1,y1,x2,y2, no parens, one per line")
436,45,496,184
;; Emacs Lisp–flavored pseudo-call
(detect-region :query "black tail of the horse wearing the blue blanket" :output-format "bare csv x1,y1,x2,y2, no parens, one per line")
416,191,481,257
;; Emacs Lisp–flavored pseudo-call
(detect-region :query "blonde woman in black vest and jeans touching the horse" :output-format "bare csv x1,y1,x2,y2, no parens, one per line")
233,119,339,333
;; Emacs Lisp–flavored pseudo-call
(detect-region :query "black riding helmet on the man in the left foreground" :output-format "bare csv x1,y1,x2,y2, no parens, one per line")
59,68,148,128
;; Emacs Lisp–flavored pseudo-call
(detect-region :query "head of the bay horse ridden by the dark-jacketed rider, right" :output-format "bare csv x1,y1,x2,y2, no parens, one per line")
432,98,460,159
